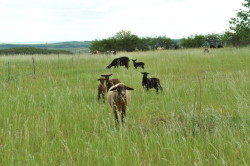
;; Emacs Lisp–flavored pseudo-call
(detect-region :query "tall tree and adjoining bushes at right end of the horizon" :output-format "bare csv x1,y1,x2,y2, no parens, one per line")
182,0,250,48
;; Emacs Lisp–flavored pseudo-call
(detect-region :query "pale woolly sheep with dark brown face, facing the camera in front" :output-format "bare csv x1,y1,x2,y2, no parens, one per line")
108,83,134,124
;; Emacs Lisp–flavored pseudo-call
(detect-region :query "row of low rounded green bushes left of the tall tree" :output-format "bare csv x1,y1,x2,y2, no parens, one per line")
90,30,226,52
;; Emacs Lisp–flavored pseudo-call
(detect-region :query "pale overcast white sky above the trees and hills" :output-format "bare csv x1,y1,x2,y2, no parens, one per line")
0,0,244,43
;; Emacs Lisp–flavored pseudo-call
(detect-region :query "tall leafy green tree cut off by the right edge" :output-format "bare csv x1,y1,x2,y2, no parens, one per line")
224,0,250,45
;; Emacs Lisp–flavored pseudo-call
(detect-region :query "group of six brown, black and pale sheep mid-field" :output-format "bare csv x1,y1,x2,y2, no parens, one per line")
97,57,162,124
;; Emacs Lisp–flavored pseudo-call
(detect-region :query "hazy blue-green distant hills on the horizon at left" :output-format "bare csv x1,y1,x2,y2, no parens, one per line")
0,41,92,49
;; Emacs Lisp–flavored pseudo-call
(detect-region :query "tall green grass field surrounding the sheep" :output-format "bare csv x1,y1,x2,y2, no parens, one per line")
0,47,250,166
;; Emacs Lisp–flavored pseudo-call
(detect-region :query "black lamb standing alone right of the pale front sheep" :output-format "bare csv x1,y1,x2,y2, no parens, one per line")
141,72,163,94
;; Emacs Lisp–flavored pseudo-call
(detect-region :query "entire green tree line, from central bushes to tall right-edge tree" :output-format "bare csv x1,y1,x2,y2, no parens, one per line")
90,0,250,52
